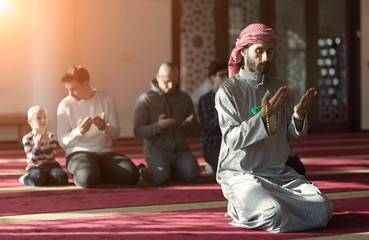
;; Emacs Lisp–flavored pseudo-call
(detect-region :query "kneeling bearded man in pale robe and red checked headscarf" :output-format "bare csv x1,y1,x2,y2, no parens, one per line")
215,23,333,232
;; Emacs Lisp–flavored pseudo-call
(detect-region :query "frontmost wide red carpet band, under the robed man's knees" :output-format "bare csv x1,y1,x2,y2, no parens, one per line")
0,198,369,240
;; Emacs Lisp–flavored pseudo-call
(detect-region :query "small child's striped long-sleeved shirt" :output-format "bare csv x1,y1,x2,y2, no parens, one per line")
22,132,58,170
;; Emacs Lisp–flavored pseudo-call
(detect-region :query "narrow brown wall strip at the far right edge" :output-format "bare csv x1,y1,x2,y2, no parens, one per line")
361,0,369,130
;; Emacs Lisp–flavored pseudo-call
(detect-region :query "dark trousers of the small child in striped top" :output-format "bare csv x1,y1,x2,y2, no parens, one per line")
23,162,68,186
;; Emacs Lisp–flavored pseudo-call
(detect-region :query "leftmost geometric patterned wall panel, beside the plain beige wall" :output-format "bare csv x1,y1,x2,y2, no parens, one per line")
180,0,215,93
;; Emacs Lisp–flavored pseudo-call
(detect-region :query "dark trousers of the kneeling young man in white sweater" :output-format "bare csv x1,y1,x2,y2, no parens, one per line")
67,152,139,188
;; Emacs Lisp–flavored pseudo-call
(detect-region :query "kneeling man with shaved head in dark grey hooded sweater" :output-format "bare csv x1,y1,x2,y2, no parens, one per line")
133,63,200,184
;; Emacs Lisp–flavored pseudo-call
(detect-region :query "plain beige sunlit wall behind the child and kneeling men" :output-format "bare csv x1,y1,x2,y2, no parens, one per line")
0,0,171,140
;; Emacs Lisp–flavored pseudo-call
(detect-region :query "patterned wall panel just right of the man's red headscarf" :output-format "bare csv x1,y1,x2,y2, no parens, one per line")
272,0,306,103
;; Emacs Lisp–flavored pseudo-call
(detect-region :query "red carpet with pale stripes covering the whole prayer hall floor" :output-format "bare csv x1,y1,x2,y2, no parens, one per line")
0,133,369,240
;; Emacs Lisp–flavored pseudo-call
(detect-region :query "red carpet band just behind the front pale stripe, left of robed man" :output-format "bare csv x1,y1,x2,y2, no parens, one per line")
0,183,224,216
